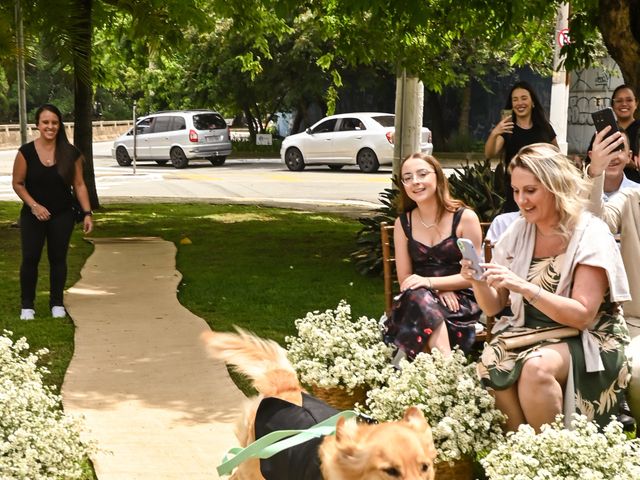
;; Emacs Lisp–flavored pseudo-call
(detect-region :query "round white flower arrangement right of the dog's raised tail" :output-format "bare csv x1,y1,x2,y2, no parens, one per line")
285,300,393,392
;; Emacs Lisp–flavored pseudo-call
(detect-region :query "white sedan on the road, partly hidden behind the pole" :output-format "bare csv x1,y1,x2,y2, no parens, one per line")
280,113,433,173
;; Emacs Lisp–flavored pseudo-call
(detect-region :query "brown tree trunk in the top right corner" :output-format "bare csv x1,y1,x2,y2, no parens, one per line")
598,0,640,105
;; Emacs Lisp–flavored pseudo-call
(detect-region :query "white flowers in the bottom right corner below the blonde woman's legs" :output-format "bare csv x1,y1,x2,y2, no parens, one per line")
480,414,640,480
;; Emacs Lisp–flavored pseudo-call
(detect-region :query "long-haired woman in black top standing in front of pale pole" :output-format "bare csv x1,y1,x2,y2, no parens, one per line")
484,81,558,212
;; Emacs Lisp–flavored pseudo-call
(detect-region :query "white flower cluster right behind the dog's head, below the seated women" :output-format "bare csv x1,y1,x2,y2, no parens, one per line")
365,349,505,462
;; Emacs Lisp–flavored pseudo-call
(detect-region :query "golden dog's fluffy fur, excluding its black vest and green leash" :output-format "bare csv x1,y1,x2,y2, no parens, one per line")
203,329,436,480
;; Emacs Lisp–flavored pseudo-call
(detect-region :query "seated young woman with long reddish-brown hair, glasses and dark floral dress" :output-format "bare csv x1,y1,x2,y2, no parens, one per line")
386,153,482,359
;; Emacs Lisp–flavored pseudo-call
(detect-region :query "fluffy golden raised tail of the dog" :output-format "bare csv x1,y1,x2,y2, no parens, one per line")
202,327,302,403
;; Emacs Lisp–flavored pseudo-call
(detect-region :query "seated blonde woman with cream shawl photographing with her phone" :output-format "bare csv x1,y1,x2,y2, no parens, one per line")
461,143,630,431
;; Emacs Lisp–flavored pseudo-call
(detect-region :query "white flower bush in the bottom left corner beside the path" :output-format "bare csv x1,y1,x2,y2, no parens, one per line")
0,331,92,480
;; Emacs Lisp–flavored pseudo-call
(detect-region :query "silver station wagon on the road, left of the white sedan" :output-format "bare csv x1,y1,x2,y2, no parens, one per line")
111,110,231,168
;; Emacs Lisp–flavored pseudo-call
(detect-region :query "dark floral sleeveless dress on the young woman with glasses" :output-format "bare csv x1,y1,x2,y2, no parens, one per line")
384,208,481,360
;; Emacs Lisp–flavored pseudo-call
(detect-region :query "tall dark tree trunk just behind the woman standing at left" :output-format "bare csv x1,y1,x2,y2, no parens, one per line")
72,0,100,209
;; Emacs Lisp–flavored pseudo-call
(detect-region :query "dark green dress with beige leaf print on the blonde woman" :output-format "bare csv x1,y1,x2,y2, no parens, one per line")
478,254,630,426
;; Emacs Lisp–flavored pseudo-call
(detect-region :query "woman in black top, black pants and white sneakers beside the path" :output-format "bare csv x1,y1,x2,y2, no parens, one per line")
12,104,93,320
